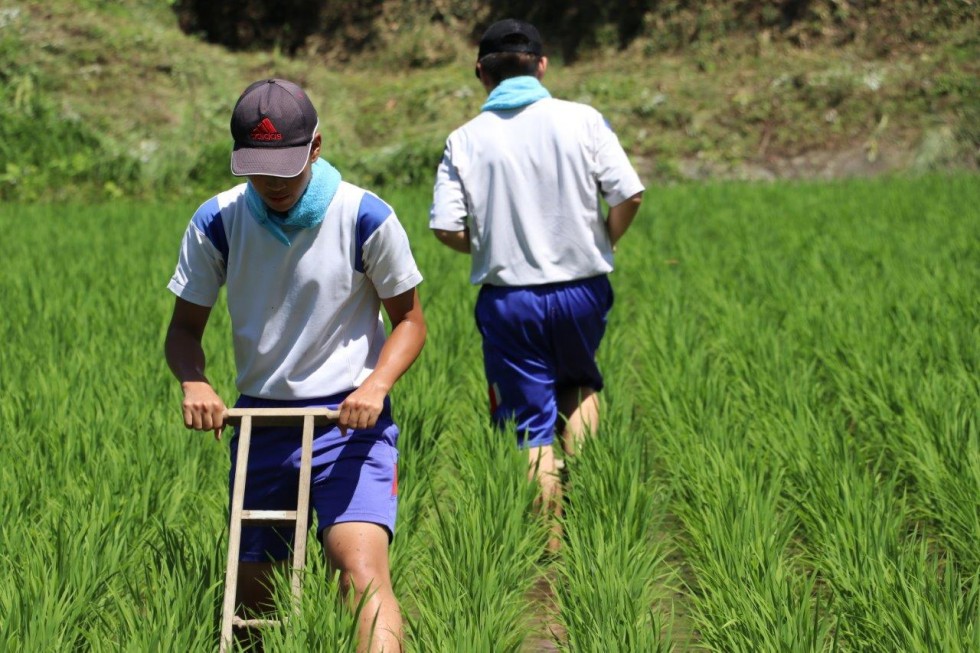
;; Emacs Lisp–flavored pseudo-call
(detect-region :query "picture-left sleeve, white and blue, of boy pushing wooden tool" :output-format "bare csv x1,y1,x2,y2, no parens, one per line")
167,201,226,306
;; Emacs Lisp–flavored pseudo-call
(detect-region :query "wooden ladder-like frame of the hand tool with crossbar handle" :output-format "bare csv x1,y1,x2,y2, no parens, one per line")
219,407,339,653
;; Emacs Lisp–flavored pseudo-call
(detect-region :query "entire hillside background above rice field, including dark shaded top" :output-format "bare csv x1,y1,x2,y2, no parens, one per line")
0,0,980,200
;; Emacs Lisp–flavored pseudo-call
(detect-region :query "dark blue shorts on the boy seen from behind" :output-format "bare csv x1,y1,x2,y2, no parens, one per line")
475,275,613,447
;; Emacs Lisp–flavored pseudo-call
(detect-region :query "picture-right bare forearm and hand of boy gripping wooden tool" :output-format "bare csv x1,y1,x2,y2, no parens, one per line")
337,288,426,435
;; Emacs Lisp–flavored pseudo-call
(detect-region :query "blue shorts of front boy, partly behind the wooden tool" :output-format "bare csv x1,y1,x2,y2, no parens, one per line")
228,393,398,562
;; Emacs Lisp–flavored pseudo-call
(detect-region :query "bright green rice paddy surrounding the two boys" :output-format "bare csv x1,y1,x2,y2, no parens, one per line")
0,175,980,653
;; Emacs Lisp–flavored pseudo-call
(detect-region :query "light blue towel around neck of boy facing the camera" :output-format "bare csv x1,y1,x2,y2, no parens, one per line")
245,159,340,247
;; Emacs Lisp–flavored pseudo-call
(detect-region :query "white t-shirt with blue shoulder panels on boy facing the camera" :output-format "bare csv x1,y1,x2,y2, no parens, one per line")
168,182,422,400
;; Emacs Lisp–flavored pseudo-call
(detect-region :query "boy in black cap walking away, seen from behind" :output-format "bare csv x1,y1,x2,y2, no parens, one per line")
429,19,644,549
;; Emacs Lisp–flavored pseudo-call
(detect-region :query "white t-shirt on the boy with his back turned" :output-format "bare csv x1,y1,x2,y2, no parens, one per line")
429,98,643,286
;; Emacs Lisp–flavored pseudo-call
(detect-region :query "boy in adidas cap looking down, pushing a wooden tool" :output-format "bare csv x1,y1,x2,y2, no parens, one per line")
165,79,426,653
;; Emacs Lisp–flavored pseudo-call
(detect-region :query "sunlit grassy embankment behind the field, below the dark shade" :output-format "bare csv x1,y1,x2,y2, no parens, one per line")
0,0,980,200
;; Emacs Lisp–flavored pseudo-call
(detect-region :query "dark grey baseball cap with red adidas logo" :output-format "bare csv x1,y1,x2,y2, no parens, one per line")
231,79,318,177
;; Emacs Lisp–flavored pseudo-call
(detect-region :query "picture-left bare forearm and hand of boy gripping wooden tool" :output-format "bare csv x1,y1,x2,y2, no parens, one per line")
164,297,225,440
